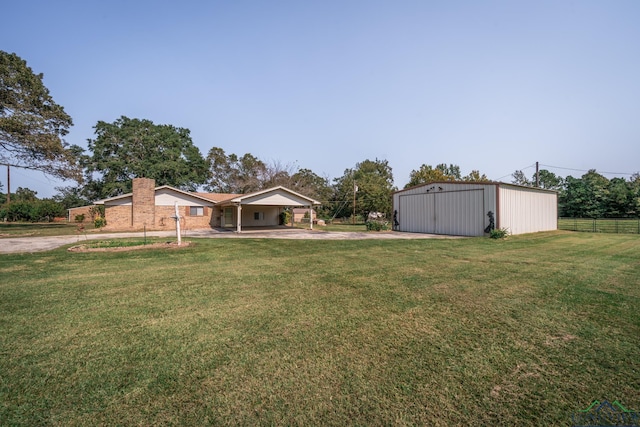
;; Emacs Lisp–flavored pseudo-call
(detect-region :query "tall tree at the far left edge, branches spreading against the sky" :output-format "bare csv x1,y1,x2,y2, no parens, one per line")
0,50,82,180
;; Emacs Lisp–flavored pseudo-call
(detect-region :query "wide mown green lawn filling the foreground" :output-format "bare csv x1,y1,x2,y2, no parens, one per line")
0,232,640,426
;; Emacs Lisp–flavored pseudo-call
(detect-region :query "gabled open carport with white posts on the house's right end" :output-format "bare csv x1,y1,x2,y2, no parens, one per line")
220,187,320,233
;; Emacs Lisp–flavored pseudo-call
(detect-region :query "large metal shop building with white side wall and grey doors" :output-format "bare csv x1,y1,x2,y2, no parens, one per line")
393,182,558,236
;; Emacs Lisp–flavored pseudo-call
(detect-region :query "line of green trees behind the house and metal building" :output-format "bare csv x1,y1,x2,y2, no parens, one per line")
0,50,640,220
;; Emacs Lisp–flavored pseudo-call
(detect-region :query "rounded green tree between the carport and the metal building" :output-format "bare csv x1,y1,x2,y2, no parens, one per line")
334,159,395,218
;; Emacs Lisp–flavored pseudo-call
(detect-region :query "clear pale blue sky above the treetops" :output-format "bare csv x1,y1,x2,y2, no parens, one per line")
0,0,640,197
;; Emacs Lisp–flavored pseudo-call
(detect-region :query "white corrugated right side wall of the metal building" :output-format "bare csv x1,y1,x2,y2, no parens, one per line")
500,186,558,234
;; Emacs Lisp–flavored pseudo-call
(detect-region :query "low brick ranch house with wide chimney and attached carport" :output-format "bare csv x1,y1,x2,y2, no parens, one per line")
79,178,320,232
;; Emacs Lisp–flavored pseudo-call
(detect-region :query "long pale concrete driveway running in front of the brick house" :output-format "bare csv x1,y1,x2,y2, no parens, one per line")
0,228,456,254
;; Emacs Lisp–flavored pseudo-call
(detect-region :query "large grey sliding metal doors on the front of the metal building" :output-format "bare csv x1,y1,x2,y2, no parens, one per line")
398,189,485,236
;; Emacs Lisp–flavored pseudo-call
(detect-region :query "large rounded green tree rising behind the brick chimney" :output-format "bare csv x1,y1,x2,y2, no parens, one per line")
82,116,208,199
